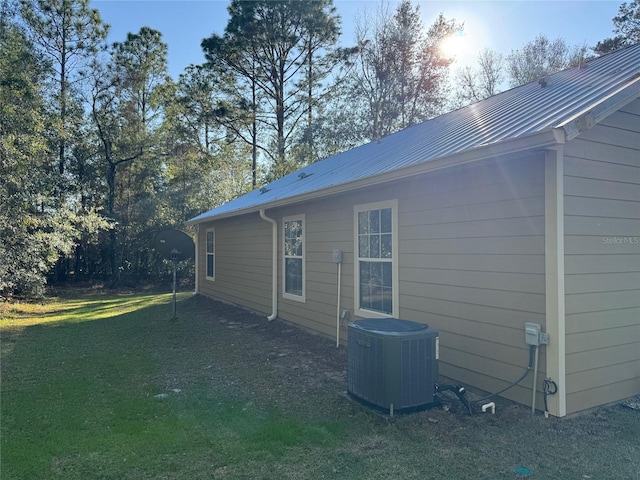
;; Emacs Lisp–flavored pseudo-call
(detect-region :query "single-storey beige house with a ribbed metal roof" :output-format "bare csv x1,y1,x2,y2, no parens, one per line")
190,44,640,417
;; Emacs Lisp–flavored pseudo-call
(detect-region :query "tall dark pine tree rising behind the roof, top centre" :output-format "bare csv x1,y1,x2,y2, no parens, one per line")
202,0,339,179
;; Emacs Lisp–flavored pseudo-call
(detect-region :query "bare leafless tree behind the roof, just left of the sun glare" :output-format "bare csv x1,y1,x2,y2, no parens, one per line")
350,0,462,139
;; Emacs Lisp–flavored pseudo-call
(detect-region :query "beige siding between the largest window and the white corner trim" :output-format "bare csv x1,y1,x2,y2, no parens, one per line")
399,158,546,403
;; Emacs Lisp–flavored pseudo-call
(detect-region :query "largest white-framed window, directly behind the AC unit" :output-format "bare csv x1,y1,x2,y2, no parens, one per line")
355,201,398,316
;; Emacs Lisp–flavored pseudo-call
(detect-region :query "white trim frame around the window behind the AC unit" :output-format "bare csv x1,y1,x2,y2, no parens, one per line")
353,199,400,318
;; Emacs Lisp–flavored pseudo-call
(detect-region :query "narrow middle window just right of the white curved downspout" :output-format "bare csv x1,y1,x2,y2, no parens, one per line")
282,216,305,302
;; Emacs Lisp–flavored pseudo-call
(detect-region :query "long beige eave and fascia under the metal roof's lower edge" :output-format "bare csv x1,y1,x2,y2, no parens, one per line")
187,128,566,225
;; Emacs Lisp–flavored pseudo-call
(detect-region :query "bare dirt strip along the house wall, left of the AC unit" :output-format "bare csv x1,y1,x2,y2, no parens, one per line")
175,296,347,409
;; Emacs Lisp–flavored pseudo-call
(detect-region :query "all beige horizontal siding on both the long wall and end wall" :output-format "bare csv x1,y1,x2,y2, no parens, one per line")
191,101,640,413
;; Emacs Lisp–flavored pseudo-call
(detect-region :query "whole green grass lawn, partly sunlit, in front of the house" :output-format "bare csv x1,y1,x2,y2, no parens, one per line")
0,294,640,480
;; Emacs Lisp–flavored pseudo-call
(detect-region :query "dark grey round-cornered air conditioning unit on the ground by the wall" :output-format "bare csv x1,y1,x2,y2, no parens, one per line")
347,318,439,415
